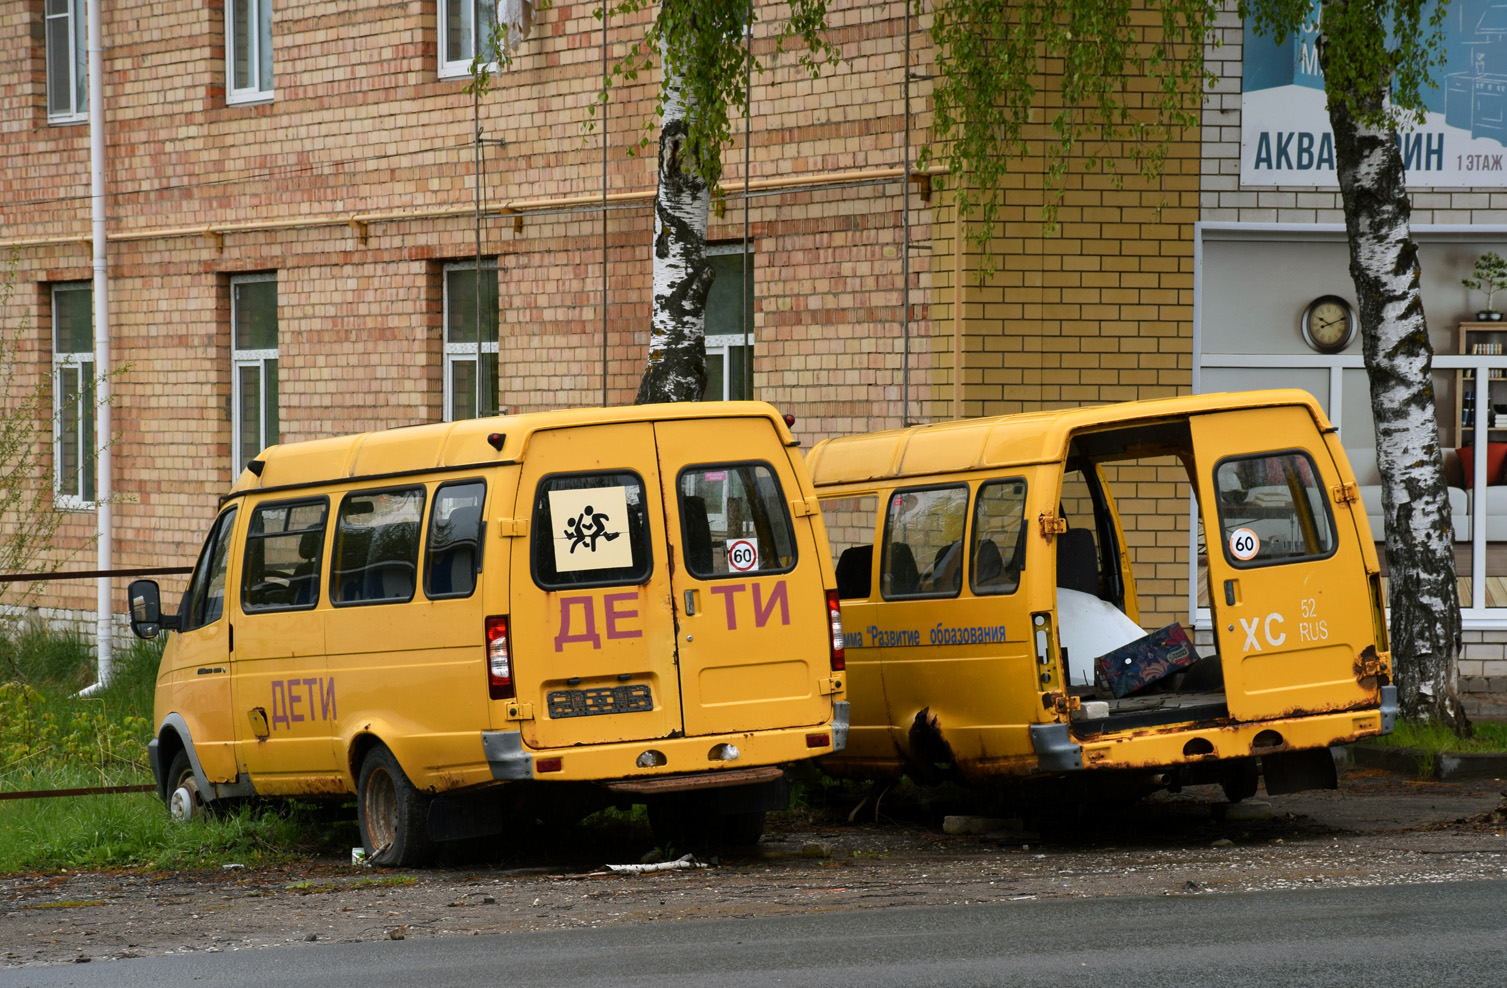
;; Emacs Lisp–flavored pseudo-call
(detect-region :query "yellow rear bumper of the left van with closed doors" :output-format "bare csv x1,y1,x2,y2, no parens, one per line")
482,716,845,788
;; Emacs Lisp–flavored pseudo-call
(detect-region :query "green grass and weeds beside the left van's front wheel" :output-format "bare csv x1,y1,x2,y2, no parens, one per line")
0,633,346,874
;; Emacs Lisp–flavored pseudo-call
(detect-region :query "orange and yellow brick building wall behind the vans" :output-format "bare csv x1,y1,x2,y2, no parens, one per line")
0,0,1200,632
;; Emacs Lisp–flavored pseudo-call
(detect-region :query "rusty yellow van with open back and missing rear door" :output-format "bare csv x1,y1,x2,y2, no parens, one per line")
806,392,1397,798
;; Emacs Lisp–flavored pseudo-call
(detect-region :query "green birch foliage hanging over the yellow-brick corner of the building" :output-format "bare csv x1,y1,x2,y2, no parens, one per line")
921,0,1221,256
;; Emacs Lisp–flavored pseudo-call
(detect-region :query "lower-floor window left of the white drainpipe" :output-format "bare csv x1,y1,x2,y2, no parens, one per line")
53,282,96,508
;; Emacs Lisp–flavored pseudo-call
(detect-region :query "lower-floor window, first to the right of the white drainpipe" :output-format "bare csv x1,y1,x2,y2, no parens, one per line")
231,274,279,471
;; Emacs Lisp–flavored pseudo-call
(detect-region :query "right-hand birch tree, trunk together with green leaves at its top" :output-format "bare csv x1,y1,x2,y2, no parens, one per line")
1240,0,1469,733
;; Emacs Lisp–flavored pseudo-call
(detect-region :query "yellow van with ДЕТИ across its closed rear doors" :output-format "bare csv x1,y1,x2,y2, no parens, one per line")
130,402,847,865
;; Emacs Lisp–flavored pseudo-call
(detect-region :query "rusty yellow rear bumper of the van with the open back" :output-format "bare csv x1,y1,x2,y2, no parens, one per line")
1074,697,1394,770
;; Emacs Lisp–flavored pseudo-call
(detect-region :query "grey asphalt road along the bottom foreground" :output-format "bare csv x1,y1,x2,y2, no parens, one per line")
0,881,1507,988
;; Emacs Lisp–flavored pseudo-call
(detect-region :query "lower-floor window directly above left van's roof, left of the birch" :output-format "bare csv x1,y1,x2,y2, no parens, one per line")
445,258,497,422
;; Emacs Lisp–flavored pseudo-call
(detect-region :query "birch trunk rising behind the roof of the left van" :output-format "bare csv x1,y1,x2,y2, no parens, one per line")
634,53,716,405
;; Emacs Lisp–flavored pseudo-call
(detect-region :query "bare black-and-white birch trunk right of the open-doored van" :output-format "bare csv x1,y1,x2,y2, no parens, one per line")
1325,63,1469,733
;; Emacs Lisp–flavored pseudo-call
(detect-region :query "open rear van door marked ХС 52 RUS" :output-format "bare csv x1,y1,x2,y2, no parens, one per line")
1191,407,1376,721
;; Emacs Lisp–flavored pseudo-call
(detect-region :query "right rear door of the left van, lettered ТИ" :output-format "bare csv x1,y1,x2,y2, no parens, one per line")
654,417,833,735
